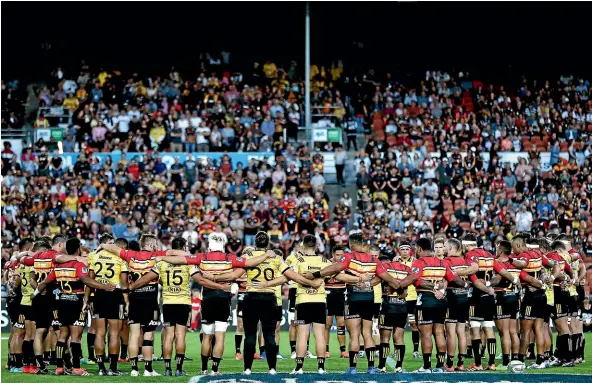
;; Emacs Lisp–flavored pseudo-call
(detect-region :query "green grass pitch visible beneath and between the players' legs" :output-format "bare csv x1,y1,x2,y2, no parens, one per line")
2,332,592,383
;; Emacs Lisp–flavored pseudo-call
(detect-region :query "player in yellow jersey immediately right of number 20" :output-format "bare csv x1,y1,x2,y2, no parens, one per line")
253,234,330,374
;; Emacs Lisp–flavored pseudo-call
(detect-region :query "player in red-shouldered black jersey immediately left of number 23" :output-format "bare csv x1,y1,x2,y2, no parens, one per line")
32,238,116,376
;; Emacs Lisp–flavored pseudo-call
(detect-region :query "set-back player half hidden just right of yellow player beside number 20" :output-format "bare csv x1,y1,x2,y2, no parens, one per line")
325,246,348,358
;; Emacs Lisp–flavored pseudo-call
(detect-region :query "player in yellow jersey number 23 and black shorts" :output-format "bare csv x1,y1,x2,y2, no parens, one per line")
86,234,130,376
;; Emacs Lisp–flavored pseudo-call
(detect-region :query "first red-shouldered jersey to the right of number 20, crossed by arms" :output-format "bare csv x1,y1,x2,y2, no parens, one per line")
337,251,386,301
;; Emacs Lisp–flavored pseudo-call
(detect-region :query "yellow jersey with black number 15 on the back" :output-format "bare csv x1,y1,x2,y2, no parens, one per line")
151,262,199,305
